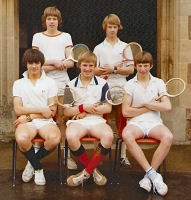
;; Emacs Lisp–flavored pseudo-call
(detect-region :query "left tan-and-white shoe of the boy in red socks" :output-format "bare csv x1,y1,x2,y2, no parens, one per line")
67,169,90,187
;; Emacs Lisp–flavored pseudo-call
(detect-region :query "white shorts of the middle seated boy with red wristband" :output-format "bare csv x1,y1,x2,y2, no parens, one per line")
66,115,106,130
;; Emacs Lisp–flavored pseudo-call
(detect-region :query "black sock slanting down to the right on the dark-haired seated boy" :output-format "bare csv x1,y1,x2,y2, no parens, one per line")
21,146,42,170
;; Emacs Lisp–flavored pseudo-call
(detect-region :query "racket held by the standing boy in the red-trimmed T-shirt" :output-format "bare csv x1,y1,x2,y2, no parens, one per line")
66,44,89,62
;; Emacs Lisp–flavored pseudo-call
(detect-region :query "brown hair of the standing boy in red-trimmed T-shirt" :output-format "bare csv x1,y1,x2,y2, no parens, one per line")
42,6,62,28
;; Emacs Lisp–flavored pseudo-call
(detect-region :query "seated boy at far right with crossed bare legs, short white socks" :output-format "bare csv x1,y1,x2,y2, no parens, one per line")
122,51,173,196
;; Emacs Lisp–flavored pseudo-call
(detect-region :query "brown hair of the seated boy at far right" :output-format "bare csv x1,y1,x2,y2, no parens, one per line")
134,51,153,66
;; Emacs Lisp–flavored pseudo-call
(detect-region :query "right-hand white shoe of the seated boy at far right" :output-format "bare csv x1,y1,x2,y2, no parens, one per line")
152,173,168,196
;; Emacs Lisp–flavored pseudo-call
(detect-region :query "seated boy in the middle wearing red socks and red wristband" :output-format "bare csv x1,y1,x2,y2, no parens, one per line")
64,51,113,186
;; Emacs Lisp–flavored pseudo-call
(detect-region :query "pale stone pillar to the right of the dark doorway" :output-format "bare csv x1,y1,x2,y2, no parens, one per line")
157,0,191,144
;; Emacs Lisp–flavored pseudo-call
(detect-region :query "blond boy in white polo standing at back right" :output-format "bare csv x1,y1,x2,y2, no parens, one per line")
94,14,134,167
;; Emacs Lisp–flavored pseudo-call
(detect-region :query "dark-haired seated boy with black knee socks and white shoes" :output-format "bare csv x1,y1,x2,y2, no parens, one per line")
13,49,61,185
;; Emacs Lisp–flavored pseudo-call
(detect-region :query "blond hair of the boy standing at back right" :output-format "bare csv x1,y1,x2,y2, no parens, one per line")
102,14,123,31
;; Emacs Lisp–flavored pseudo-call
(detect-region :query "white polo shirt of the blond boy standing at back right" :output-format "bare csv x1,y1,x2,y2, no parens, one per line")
94,38,134,87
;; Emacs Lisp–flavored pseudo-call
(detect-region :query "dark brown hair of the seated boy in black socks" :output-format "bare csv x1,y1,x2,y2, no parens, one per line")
22,49,45,66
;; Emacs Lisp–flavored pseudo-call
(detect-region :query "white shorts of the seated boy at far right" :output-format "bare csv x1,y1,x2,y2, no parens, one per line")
127,121,163,138
